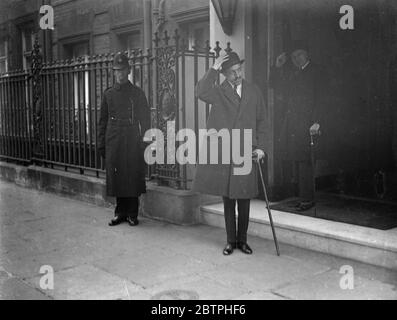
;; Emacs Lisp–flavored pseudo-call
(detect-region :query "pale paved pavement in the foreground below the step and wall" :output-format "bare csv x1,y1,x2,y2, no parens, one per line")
0,181,397,300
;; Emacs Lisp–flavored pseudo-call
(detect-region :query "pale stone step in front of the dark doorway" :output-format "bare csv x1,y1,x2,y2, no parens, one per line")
200,200,397,269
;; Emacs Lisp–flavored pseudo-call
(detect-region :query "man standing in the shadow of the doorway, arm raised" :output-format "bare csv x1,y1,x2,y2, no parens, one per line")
269,41,326,211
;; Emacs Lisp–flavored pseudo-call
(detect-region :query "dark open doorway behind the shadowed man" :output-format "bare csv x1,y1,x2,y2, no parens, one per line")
253,0,397,229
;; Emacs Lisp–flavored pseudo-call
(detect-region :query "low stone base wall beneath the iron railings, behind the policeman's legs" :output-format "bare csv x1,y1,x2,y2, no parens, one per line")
0,162,220,225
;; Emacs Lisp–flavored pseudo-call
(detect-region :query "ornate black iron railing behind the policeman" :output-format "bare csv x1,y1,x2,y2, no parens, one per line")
0,31,232,189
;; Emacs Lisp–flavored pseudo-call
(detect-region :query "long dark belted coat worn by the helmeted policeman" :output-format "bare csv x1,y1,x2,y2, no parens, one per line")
98,81,150,197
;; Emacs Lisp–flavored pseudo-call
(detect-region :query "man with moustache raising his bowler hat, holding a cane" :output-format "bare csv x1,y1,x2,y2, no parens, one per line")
193,52,266,255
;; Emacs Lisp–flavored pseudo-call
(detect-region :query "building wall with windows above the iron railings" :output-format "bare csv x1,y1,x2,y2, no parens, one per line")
0,0,209,71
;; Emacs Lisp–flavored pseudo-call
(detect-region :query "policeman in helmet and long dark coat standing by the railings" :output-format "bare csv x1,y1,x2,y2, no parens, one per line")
98,53,150,226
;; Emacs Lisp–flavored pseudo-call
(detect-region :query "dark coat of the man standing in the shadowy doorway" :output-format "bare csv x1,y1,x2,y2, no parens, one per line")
270,62,328,161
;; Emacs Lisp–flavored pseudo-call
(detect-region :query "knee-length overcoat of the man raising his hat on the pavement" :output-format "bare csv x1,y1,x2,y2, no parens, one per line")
193,68,266,199
